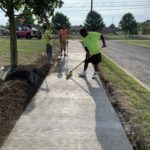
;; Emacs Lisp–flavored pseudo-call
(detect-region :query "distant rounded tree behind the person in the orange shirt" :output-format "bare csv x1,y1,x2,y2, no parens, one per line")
52,12,71,31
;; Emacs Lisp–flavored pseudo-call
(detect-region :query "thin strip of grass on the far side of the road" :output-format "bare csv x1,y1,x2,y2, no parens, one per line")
126,40,150,47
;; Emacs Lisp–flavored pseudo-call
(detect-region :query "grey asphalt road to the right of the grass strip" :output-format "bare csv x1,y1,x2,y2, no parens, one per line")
103,41,150,88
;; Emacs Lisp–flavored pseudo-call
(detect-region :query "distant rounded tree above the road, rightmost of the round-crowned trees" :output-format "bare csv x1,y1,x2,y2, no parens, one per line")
119,13,138,35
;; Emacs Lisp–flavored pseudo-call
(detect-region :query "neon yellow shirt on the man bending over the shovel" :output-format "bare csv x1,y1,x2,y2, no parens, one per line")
82,32,101,56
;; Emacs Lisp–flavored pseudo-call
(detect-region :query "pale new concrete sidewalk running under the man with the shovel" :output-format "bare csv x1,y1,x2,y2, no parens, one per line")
1,41,132,150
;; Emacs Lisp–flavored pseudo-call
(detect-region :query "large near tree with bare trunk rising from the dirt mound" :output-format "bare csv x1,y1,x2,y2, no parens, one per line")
0,0,63,67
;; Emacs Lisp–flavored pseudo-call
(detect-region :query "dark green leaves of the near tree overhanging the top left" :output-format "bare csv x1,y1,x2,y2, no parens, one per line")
0,0,63,22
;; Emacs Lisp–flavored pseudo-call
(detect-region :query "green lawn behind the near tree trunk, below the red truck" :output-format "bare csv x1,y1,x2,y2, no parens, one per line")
0,37,58,66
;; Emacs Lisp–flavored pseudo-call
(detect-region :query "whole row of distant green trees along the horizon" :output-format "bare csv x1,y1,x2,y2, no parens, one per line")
1,8,150,35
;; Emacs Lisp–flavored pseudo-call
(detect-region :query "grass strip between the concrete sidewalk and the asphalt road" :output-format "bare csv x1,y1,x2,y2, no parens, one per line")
100,53,150,146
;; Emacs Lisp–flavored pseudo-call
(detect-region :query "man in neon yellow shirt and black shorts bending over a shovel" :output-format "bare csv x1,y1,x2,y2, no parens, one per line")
79,29,106,79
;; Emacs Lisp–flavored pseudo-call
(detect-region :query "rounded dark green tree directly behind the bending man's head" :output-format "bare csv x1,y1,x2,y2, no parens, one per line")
84,11,105,31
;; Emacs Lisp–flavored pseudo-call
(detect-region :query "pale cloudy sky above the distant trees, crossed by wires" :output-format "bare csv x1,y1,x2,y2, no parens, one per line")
0,0,150,27
